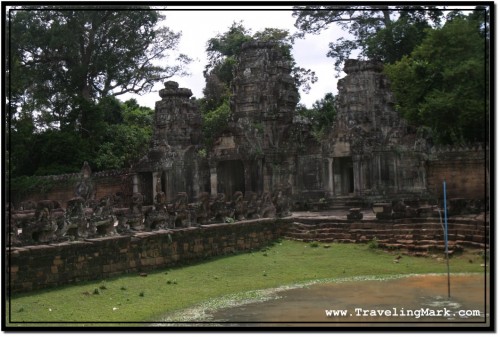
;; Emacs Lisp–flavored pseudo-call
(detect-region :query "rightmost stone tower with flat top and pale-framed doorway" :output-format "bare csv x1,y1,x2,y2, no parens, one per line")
325,60,426,196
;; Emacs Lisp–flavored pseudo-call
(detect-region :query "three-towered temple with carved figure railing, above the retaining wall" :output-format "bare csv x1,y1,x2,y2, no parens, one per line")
8,42,489,245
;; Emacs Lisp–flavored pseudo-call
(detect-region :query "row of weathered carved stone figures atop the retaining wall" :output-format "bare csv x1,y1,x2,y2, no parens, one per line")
6,190,291,246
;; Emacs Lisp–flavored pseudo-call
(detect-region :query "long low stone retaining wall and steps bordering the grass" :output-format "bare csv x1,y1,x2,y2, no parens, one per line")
6,213,490,293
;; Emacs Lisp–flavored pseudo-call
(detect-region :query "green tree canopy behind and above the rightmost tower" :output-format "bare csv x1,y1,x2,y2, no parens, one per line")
293,5,489,144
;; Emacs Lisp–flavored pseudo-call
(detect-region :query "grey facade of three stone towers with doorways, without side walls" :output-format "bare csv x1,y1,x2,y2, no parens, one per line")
134,42,480,206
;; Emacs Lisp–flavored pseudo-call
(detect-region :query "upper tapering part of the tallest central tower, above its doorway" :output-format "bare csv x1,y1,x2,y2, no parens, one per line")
231,42,299,153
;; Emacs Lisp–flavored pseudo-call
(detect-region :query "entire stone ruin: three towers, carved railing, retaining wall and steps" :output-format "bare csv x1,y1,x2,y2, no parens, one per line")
4,42,489,291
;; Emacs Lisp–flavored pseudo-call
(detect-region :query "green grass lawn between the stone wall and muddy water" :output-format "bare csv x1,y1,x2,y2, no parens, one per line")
7,241,484,326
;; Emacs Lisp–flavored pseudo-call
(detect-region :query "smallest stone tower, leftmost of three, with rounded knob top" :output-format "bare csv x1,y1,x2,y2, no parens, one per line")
134,81,201,204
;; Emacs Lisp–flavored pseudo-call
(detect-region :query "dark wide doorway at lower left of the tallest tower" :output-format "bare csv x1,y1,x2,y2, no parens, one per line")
217,160,245,200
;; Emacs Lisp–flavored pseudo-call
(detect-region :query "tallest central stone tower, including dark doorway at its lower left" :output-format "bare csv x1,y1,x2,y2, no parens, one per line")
209,41,299,200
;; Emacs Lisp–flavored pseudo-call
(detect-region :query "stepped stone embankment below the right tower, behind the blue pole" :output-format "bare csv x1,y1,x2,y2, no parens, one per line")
285,213,490,255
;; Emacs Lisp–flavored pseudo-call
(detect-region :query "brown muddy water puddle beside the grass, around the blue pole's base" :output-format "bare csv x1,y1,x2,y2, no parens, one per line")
210,274,489,326
